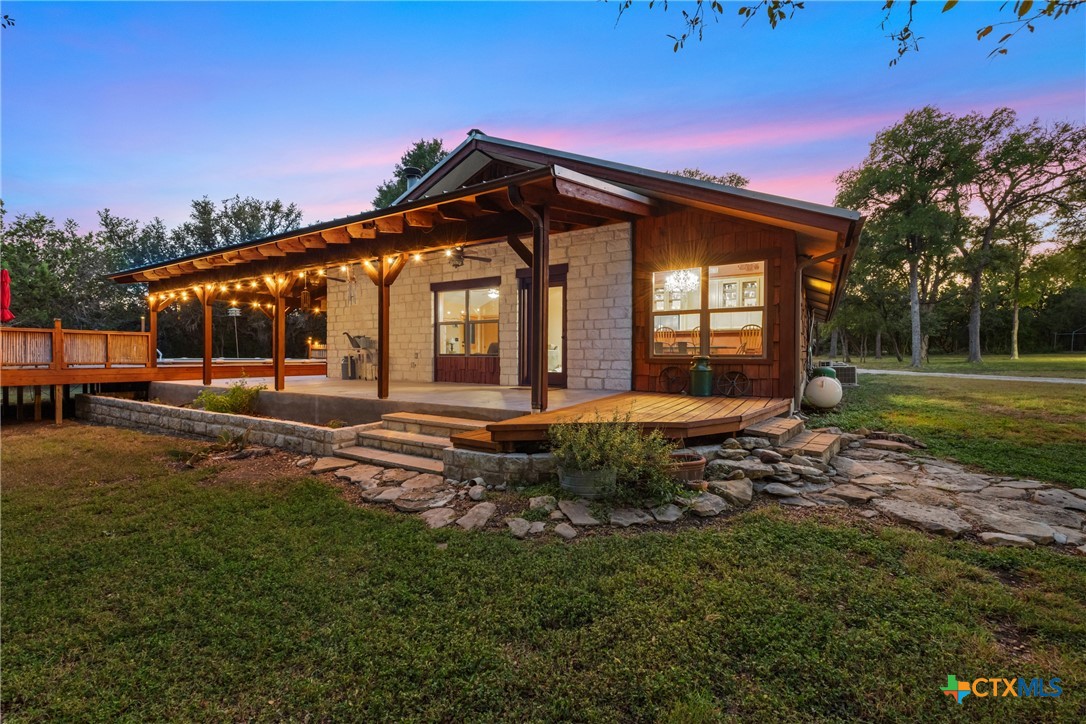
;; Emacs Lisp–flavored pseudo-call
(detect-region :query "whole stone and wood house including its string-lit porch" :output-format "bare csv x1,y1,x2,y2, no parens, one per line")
105,130,863,434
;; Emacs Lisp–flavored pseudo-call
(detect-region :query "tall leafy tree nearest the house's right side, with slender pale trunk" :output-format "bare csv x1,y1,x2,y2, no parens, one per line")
836,106,975,367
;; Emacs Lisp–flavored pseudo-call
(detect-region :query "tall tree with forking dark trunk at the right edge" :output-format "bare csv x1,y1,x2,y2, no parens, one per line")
960,109,1086,363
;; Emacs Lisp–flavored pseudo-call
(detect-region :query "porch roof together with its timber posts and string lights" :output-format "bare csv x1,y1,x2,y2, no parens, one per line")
112,165,656,412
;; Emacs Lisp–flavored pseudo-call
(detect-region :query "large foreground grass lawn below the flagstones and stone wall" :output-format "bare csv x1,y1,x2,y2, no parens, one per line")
2,424,1086,722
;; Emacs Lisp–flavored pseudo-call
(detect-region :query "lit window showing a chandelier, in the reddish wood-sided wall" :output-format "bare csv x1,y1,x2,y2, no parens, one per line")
652,262,766,357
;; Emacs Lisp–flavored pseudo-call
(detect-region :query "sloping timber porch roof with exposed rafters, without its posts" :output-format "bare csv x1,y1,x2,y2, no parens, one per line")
110,166,656,297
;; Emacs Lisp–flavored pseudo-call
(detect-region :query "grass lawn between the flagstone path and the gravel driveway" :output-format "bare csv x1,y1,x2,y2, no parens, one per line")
808,373,1086,487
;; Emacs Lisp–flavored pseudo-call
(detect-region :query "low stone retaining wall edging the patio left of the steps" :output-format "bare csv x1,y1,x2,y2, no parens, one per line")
75,395,358,455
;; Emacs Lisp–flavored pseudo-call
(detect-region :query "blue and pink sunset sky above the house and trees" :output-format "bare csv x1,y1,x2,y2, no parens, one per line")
0,0,1086,228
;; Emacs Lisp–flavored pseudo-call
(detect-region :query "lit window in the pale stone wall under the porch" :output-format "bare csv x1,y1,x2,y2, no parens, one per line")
434,284,500,357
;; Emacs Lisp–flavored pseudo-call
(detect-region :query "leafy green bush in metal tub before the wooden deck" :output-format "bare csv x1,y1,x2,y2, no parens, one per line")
547,412,682,503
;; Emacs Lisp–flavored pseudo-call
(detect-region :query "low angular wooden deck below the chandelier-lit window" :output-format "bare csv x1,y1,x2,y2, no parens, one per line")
452,392,792,452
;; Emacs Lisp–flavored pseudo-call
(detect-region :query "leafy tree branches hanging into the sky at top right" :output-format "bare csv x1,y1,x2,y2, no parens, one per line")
618,0,1086,65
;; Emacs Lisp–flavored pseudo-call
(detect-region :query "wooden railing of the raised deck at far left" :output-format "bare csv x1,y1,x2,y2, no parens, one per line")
0,319,155,369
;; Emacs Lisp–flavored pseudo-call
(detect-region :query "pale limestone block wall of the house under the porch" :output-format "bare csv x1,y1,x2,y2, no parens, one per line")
328,224,633,391
